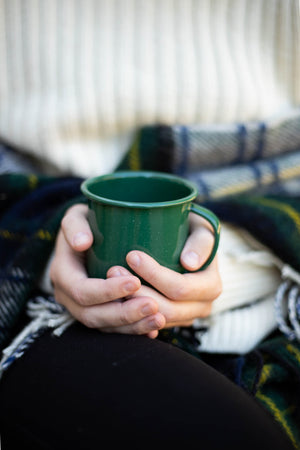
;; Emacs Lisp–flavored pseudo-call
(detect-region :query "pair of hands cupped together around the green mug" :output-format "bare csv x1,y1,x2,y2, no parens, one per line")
51,205,221,338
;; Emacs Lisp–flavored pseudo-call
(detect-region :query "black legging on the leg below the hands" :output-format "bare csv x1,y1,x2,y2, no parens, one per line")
0,324,293,450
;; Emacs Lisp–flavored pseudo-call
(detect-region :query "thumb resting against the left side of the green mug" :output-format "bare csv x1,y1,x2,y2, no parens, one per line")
61,204,93,251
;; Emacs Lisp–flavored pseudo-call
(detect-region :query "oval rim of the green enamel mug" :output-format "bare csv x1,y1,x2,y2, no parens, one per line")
80,170,198,209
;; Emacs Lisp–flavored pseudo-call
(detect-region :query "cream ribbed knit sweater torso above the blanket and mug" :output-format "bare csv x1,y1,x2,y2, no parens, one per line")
0,0,300,176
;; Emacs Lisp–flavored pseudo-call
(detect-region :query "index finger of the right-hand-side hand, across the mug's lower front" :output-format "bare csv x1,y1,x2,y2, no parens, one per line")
126,250,222,302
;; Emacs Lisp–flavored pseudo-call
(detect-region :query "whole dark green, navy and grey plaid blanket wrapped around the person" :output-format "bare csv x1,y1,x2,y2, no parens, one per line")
0,111,300,449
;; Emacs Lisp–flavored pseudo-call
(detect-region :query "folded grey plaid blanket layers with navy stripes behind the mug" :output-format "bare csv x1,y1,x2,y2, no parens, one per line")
120,108,300,201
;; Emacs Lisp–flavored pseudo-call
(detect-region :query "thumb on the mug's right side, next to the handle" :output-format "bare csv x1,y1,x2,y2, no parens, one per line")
180,214,215,271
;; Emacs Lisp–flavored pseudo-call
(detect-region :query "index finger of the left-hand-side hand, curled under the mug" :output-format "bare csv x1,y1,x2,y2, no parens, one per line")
50,233,141,306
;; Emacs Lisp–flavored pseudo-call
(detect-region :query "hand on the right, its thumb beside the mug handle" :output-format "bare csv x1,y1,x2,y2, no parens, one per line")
106,214,222,337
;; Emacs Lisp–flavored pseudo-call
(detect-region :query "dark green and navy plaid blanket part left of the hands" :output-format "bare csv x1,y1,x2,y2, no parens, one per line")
0,174,82,348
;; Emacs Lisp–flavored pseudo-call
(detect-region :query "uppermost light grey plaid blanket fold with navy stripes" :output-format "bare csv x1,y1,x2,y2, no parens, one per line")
166,109,300,172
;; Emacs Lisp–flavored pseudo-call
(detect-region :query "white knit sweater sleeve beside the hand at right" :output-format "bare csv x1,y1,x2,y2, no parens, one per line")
194,224,284,353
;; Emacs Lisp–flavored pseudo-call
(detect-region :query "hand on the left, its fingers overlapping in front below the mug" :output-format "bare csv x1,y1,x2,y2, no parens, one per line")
50,204,165,338
